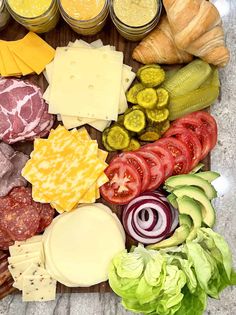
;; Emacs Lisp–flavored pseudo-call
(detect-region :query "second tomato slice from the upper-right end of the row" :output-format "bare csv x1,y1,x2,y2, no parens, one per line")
172,113,212,160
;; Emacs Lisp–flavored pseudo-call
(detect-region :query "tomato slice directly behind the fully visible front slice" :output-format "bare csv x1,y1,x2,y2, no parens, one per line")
112,152,151,192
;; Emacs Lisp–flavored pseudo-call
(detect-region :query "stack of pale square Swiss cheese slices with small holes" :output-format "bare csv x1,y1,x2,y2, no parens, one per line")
44,40,135,131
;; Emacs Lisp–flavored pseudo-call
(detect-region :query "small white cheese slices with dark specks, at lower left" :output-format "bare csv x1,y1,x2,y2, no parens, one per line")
8,235,56,301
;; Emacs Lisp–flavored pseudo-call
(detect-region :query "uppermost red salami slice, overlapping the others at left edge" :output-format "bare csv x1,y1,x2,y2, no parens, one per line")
0,202,40,241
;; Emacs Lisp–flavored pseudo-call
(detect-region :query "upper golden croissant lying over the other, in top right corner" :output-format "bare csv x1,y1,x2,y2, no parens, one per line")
163,0,229,66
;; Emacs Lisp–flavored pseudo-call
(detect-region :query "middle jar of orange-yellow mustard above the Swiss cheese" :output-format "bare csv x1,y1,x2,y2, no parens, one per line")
58,0,109,35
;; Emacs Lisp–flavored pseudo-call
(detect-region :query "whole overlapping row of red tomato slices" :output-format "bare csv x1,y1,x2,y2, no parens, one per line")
100,111,217,205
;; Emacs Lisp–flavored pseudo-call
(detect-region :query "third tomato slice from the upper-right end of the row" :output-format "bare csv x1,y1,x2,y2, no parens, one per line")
164,126,202,170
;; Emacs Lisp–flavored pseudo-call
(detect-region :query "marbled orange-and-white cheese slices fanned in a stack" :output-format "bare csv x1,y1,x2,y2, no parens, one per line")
22,125,108,212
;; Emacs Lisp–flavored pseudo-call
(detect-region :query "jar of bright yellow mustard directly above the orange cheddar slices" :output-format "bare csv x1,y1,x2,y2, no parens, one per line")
5,0,60,33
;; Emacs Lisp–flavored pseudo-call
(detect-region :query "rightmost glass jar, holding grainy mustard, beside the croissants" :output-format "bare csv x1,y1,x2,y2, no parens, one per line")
110,0,162,41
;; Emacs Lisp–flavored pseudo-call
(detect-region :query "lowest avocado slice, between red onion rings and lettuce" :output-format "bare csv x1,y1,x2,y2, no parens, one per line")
147,225,190,249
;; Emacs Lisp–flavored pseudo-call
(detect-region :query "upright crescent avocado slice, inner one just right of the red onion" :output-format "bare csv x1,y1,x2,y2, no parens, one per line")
176,196,202,240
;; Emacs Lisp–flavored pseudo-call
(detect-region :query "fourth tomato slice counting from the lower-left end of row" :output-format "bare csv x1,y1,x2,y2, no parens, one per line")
142,142,175,179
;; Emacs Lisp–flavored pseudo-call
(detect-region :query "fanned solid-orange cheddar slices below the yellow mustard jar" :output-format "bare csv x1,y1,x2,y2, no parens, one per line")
0,32,55,77
